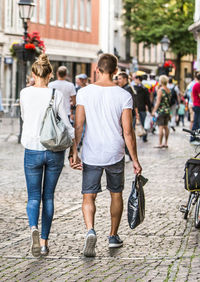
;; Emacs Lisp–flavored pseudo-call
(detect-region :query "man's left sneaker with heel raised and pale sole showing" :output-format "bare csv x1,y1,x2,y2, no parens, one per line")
83,229,97,257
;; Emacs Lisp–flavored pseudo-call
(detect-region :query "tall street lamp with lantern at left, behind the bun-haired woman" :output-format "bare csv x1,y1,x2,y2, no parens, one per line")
18,0,35,143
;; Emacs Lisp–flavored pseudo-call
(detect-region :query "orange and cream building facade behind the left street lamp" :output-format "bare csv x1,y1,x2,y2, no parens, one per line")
0,0,100,111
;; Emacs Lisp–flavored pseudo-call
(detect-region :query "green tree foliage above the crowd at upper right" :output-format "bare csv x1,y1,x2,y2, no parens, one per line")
123,0,196,58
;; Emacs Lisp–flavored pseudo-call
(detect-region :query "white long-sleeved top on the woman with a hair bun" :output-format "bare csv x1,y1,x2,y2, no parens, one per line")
20,86,74,151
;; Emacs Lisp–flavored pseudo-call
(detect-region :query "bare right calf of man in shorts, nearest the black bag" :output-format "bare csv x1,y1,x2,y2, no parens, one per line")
110,192,123,236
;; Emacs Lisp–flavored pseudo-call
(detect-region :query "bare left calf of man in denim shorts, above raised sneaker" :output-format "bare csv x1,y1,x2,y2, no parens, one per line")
82,194,97,230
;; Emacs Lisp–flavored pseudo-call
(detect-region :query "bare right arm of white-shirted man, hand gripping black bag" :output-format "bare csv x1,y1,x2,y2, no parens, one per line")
122,109,142,174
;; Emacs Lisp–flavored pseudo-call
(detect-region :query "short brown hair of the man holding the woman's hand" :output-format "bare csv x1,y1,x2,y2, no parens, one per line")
97,54,118,75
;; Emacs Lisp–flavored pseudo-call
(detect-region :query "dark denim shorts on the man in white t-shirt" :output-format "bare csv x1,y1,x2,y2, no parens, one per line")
82,158,124,194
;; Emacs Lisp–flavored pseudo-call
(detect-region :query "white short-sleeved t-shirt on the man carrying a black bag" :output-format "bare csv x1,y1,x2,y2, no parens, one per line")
76,84,133,166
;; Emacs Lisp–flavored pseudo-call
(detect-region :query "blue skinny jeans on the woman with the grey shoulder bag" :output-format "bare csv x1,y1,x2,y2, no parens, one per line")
24,149,65,240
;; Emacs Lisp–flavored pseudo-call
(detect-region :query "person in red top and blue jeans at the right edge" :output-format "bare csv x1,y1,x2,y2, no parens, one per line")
190,73,200,145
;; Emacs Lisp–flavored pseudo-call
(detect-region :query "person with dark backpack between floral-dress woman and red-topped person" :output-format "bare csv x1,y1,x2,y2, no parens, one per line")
167,77,179,131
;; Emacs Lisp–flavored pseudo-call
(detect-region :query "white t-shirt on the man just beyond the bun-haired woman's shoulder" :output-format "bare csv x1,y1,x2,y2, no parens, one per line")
48,80,76,115
